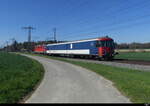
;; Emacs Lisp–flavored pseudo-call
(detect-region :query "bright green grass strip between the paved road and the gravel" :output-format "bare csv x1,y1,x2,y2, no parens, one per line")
27,55,150,103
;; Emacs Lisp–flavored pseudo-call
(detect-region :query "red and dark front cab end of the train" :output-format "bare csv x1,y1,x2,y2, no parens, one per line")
97,37,115,60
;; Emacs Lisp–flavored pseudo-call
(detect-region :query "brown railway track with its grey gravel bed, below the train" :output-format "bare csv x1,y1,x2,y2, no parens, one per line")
54,58,150,72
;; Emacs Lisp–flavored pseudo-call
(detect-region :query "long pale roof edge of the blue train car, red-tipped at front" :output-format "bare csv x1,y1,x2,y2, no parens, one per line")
47,36,111,46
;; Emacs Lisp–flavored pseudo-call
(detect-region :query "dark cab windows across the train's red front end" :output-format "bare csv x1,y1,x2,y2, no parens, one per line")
96,40,115,48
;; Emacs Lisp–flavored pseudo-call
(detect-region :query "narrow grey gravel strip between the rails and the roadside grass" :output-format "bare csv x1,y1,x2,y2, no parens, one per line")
67,58,150,72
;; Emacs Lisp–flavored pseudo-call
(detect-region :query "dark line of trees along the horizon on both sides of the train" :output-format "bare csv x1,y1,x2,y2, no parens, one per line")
0,40,150,52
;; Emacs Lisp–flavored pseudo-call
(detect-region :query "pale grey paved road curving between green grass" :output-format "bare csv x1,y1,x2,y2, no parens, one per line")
22,55,130,103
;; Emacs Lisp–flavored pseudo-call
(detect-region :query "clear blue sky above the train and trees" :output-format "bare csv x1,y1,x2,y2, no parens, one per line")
0,0,150,46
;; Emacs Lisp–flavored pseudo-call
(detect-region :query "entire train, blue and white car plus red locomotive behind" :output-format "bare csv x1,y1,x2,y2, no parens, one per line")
34,37,116,60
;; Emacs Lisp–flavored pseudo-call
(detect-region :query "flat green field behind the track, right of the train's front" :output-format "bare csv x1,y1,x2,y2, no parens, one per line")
115,52,150,61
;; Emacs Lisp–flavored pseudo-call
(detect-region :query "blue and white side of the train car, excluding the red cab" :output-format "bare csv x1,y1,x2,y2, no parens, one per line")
47,39,98,56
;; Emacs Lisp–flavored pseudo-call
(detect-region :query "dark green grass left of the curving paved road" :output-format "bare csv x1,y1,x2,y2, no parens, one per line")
0,52,44,103
